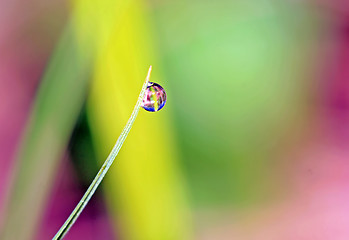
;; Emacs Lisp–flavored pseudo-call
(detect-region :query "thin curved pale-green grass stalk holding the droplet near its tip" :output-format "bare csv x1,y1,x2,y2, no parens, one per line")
52,66,152,240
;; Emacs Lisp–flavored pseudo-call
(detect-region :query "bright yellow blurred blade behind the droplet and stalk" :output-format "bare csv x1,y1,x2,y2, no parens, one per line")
88,1,188,240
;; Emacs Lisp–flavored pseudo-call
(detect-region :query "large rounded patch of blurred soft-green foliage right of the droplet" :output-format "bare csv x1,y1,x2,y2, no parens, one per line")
155,1,316,205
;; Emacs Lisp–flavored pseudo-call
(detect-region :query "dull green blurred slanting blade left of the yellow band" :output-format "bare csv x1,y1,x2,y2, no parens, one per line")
1,26,89,240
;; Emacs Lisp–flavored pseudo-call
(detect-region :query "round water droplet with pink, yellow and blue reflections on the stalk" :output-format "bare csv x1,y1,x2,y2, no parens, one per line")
142,82,166,112
